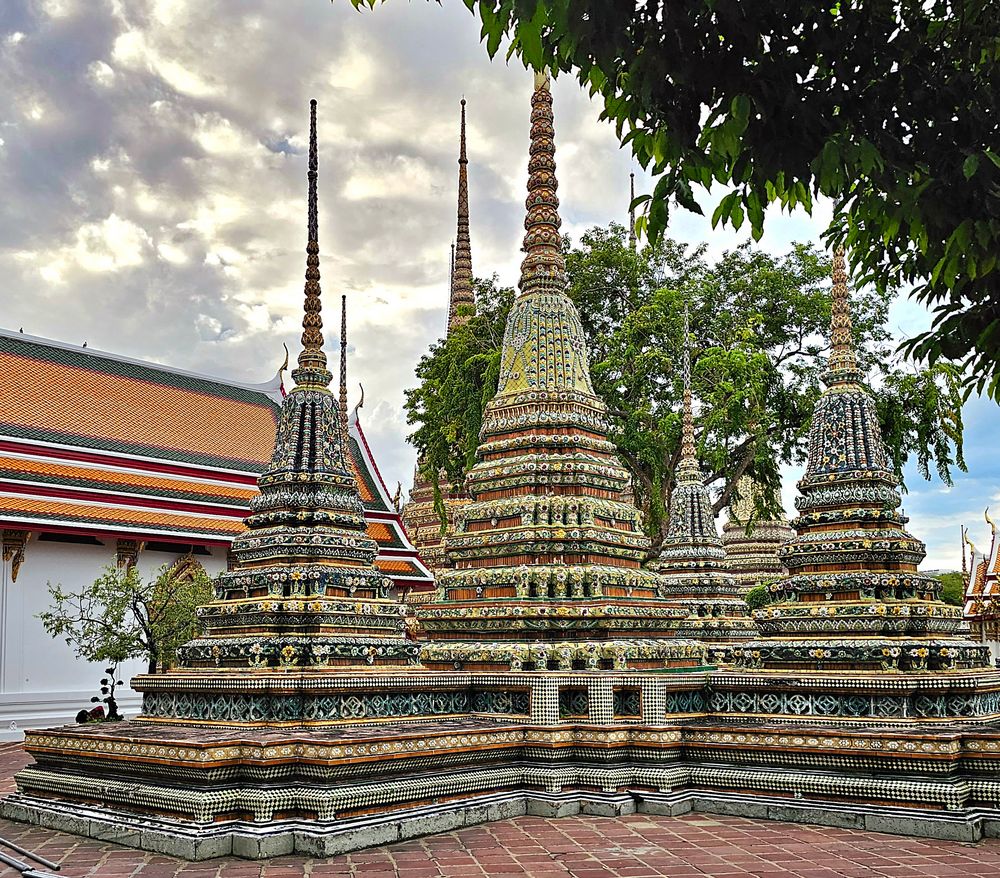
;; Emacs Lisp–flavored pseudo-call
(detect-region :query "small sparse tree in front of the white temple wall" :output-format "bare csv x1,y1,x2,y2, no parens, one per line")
38,558,214,674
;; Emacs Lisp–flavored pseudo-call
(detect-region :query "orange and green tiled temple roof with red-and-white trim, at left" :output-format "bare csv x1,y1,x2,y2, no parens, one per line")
0,329,433,588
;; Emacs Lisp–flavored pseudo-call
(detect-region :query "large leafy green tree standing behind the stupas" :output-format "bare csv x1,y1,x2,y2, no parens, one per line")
407,230,965,547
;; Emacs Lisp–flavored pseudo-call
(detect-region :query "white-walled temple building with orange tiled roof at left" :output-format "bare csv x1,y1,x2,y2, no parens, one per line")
0,300,433,739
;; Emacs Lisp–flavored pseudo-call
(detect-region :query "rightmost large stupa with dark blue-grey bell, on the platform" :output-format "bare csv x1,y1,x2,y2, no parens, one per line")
737,249,989,672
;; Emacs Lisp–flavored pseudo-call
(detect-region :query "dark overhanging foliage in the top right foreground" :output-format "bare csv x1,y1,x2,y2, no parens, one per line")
353,0,1000,400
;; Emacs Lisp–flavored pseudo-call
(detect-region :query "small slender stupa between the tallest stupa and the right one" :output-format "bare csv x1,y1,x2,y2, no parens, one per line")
649,307,757,663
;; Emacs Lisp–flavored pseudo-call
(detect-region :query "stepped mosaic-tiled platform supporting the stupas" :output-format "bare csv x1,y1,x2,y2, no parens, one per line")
2,671,1000,860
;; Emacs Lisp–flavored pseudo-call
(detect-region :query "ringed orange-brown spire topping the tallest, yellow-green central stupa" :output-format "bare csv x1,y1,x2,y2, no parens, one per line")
519,72,566,295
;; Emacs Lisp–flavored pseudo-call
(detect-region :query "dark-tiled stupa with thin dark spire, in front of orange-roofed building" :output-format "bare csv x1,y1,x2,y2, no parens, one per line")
172,101,416,672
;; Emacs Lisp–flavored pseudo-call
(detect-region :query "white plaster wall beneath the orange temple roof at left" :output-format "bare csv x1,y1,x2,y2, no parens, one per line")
0,534,226,741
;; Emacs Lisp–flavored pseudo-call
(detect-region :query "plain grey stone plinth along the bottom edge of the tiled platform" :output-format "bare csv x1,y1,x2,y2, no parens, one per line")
3,791,1000,861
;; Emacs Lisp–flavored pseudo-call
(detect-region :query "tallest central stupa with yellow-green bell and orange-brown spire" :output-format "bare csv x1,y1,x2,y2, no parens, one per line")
417,76,703,670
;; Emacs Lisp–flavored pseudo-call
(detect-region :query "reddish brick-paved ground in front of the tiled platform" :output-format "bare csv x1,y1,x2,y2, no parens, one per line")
0,745,1000,878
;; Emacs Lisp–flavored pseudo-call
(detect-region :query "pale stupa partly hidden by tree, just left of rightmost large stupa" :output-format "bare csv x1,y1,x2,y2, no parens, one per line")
722,476,795,592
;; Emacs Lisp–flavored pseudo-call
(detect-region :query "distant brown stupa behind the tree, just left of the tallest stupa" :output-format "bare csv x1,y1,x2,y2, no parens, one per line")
403,98,476,575
